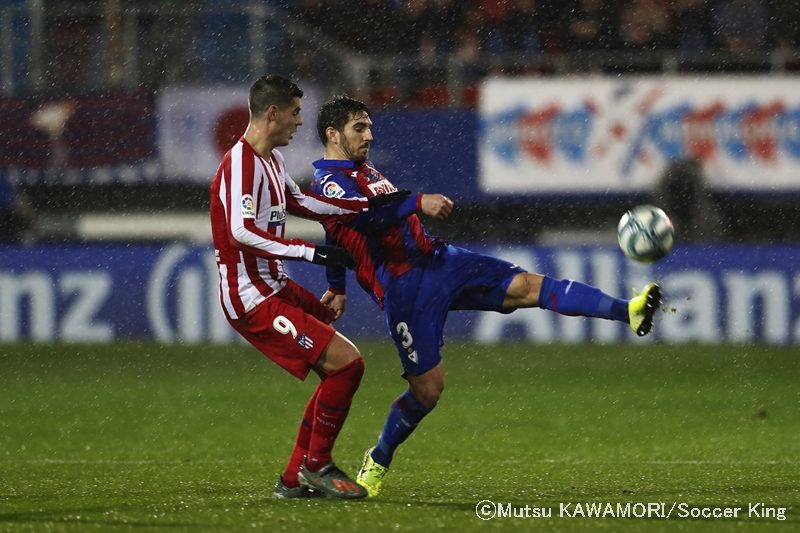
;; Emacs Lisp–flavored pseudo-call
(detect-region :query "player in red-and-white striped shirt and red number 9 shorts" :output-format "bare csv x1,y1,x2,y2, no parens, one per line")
211,76,390,498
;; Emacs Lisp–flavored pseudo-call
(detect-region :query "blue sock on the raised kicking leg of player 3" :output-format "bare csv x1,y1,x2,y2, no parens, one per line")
539,276,630,323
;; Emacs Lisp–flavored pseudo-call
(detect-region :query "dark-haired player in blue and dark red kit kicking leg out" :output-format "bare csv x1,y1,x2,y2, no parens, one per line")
312,96,661,496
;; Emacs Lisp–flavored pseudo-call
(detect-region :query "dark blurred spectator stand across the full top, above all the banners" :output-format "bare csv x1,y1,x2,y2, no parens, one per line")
9,0,800,106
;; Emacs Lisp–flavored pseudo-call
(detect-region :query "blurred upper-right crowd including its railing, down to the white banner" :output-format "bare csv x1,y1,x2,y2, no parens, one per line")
284,0,800,106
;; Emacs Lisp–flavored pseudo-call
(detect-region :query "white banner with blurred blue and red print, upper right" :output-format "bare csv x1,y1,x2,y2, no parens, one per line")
478,76,800,194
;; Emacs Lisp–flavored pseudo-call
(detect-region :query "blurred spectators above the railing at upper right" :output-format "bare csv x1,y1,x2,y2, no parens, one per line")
292,0,800,59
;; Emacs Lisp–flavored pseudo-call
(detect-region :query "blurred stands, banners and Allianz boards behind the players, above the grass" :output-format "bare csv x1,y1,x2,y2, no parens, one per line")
0,0,800,343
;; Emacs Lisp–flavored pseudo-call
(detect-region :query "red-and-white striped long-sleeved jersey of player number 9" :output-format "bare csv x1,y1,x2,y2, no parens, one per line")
211,137,368,319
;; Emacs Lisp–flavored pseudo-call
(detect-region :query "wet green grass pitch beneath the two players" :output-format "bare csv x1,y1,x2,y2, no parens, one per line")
0,342,800,532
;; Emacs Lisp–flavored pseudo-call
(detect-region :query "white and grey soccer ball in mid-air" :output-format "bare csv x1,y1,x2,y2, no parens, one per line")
617,205,675,263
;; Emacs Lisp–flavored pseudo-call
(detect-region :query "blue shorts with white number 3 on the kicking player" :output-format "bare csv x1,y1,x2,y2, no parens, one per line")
383,245,525,376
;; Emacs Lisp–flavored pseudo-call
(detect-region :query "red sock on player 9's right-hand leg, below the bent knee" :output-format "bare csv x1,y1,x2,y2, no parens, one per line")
306,357,364,472
